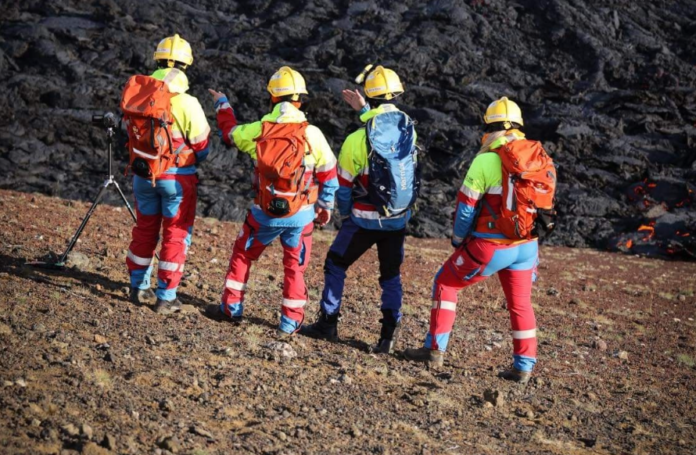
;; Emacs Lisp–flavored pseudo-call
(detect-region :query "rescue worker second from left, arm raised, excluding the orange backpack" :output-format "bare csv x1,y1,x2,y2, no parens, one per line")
210,66,338,337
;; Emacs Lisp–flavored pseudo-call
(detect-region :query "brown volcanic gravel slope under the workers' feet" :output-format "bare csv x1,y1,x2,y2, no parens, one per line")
0,191,696,455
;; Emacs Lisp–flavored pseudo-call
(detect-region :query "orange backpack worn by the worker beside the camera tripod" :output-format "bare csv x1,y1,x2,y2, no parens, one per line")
121,75,185,187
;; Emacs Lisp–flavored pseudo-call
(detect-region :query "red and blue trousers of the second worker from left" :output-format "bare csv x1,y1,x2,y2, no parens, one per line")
220,211,314,333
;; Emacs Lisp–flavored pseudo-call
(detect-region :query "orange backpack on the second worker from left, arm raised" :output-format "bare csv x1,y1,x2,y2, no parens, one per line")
256,122,317,218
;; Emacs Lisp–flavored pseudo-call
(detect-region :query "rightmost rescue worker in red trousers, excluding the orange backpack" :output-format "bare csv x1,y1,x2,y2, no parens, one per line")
404,97,538,383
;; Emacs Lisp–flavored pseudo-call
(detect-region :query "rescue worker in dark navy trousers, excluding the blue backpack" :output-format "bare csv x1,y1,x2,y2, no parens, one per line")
301,66,415,353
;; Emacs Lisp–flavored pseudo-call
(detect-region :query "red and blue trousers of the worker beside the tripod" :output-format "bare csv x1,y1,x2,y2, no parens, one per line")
126,174,198,300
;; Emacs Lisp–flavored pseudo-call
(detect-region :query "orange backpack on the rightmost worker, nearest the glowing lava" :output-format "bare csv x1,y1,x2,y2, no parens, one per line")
491,139,556,240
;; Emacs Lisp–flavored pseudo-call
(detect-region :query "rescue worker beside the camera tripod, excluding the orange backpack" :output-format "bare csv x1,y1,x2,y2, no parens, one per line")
126,35,210,314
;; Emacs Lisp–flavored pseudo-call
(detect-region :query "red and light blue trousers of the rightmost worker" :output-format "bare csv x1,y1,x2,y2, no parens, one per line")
425,237,539,371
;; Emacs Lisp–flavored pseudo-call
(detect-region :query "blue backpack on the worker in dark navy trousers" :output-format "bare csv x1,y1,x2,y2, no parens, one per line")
366,111,421,217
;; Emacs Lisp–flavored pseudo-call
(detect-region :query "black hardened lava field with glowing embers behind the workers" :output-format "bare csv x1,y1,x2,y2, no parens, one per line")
0,0,696,258
